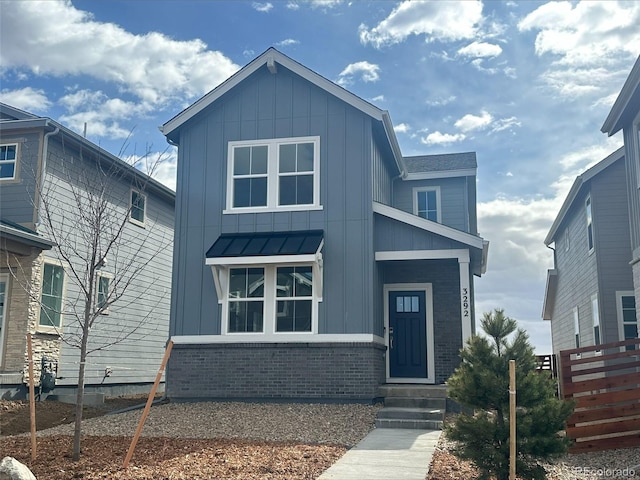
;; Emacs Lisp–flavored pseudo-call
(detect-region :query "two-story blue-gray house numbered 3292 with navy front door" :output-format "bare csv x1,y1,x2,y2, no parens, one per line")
162,48,488,401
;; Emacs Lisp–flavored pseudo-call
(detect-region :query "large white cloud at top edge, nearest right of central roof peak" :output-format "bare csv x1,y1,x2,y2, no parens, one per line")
359,1,482,48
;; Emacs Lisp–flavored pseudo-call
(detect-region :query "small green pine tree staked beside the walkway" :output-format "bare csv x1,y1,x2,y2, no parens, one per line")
446,309,573,480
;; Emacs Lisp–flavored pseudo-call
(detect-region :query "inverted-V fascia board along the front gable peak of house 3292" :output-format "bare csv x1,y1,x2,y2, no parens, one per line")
160,48,388,136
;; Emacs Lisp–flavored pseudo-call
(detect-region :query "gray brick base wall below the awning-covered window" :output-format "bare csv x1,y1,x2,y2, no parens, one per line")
166,343,385,402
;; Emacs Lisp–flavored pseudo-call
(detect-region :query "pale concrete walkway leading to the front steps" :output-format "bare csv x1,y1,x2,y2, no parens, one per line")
318,428,442,480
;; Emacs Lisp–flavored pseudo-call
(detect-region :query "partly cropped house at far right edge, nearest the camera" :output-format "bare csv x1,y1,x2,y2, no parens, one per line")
601,57,640,337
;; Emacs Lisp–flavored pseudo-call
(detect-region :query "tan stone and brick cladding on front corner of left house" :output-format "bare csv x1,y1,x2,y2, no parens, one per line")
0,249,61,385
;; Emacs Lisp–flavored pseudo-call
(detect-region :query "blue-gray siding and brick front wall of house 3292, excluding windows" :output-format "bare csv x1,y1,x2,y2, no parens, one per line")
167,56,470,401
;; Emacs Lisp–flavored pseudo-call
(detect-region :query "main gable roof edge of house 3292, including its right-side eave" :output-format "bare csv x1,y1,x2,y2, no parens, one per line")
160,47,405,172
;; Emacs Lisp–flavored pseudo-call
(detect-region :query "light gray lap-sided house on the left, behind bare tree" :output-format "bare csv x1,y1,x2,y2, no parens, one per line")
0,104,175,396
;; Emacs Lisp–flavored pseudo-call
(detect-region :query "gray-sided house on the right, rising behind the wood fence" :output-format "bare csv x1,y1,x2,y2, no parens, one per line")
542,148,637,354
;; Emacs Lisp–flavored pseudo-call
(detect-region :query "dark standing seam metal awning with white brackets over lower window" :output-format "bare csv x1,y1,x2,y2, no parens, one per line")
205,230,324,303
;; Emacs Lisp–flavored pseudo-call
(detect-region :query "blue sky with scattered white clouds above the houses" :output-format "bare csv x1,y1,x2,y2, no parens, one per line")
0,0,640,354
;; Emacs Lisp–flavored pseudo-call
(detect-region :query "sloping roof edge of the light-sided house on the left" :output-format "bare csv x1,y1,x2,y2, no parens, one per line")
0,102,176,202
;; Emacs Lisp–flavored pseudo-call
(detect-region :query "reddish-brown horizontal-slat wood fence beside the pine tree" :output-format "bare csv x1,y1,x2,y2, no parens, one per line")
560,339,640,453
